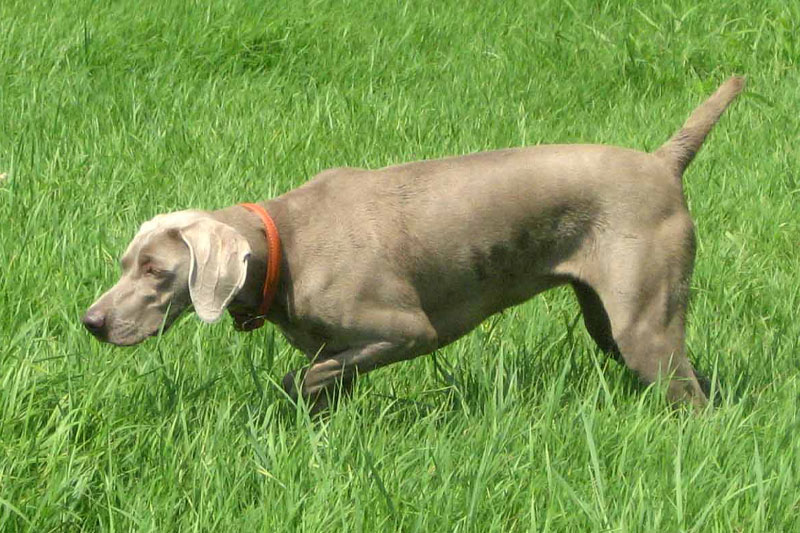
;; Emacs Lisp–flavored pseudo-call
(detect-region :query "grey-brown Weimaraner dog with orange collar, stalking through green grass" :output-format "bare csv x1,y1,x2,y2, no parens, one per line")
82,77,744,407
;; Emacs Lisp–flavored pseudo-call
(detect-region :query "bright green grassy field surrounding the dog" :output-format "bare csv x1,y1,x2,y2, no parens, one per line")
0,0,800,532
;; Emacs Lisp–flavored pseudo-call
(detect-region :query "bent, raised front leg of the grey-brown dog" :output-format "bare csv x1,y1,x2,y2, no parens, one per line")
283,341,423,413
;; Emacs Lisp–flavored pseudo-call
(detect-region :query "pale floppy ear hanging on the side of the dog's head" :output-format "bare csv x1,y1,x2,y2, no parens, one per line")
179,218,250,322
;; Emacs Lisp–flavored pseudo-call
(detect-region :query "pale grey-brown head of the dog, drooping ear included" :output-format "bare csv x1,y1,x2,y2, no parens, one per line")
81,211,250,346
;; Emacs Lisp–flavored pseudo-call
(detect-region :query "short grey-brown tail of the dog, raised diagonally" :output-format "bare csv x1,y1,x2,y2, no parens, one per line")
654,76,744,177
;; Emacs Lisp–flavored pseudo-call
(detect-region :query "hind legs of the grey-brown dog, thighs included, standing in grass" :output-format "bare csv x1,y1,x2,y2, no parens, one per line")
573,216,707,407
